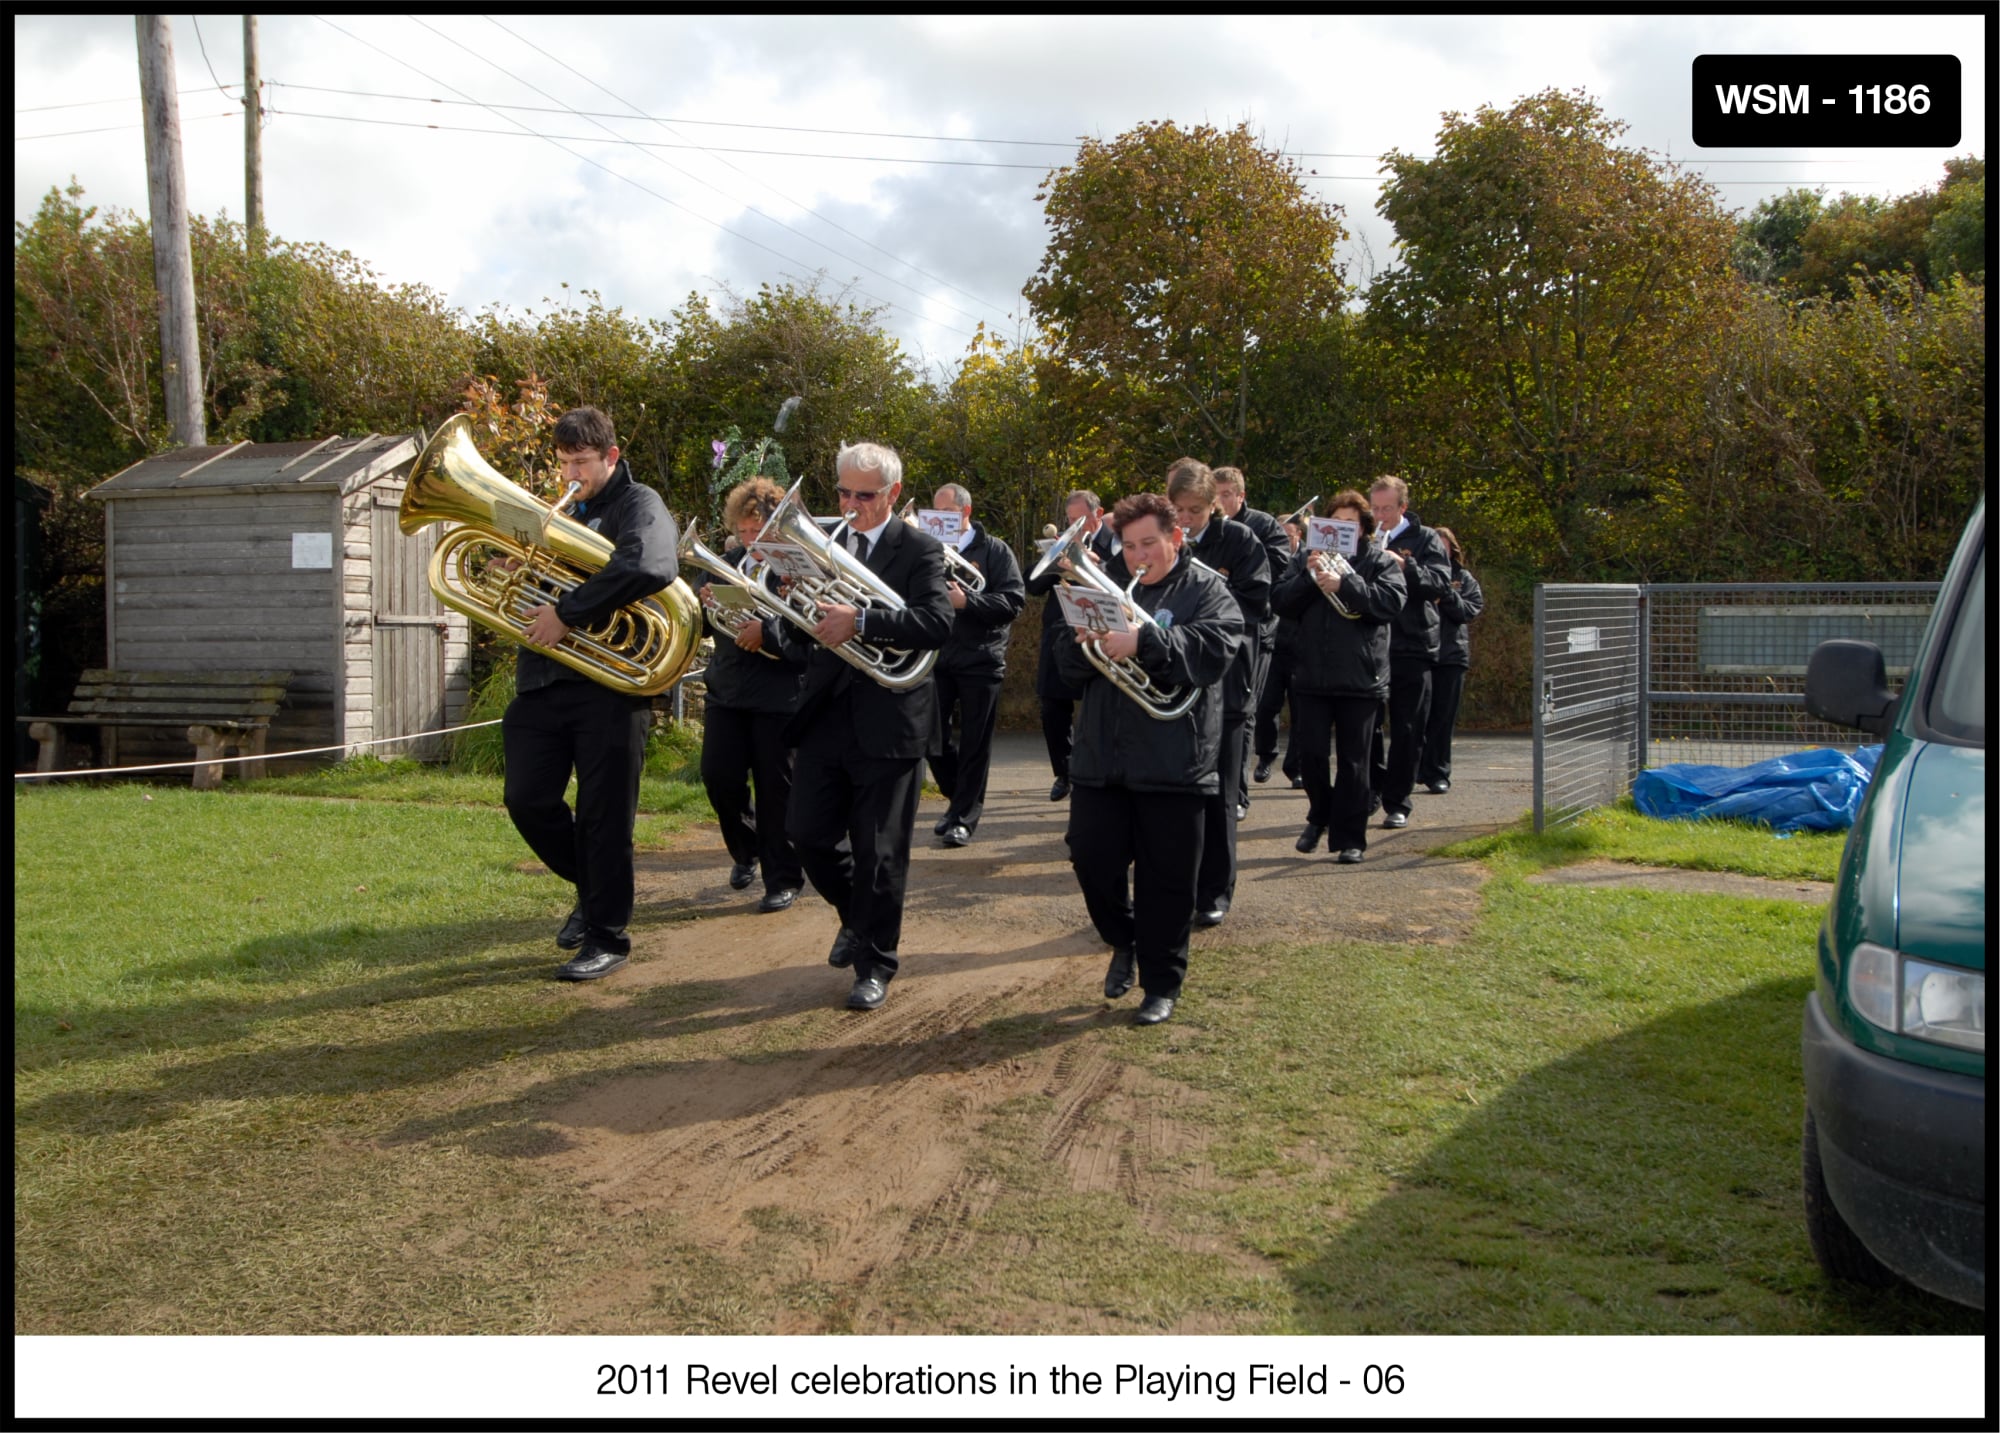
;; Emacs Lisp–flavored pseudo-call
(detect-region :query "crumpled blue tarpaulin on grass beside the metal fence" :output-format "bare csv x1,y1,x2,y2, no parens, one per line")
1632,747,1882,831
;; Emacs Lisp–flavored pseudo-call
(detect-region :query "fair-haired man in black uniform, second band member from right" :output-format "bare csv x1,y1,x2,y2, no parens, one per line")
1368,476,1452,831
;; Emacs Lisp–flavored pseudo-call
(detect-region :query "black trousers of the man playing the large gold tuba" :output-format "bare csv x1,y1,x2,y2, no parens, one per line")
500,680,652,955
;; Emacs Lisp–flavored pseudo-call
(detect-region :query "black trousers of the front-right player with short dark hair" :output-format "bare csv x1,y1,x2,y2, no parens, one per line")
1068,787,1204,999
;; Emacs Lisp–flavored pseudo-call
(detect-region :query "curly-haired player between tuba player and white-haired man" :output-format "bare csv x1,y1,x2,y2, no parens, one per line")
694,478,806,911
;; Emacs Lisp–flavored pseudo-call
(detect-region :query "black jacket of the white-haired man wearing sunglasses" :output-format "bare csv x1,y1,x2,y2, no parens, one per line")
780,518,952,759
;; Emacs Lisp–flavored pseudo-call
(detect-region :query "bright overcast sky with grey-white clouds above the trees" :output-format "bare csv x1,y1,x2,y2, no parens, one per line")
14,12,1986,378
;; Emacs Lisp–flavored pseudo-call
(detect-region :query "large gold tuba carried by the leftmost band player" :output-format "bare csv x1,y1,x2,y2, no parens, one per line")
396,412,702,696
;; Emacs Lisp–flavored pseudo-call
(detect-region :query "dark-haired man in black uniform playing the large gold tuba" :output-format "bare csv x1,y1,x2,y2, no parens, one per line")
500,408,680,981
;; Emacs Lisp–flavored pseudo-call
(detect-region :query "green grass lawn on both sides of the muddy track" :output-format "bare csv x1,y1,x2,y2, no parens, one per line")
14,784,1984,1333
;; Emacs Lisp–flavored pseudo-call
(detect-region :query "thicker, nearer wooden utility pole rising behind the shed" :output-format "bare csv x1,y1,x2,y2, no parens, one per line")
134,14,208,446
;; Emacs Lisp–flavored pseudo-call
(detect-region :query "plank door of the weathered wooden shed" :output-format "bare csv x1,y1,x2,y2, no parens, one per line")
370,488,444,761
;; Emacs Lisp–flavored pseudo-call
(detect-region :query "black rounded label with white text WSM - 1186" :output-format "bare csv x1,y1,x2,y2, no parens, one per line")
1694,54,1960,150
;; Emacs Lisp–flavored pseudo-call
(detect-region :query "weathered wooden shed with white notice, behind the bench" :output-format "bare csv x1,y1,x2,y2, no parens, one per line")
90,432,472,771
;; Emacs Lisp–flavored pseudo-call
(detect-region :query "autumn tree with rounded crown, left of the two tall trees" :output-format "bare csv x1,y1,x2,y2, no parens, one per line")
1026,120,1346,464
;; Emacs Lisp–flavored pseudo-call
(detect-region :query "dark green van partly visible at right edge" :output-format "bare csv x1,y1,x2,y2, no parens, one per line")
1804,498,1988,1309
